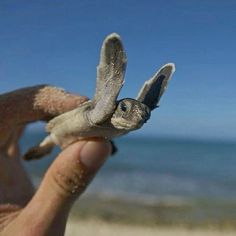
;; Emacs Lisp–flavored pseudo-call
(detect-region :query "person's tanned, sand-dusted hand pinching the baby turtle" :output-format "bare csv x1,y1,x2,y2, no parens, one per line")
0,85,111,236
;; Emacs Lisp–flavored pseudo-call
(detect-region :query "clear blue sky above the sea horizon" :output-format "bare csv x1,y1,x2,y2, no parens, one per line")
0,0,236,139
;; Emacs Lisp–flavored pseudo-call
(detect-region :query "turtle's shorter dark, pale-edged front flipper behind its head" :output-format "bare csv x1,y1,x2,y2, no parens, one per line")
136,63,175,110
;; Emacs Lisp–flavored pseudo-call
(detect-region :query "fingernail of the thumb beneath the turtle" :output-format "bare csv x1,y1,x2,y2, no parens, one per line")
80,141,110,171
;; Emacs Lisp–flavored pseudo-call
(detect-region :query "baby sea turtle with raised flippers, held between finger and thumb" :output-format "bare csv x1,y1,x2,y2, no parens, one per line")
24,33,175,160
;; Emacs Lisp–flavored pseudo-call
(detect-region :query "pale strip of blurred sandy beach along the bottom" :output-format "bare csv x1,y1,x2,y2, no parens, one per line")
66,219,236,236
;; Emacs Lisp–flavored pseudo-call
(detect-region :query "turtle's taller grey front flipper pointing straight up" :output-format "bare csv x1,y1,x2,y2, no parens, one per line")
89,33,127,124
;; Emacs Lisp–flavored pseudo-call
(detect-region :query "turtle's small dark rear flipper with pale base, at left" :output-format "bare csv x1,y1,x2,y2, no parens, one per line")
23,136,55,161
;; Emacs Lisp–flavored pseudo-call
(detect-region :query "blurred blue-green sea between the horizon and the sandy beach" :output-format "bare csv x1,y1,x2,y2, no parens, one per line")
21,132,236,226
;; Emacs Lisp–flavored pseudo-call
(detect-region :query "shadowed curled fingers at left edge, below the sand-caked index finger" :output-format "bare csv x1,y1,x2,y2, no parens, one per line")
0,126,34,206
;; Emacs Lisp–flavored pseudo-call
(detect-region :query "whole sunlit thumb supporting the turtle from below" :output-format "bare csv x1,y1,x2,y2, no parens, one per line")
14,141,111,234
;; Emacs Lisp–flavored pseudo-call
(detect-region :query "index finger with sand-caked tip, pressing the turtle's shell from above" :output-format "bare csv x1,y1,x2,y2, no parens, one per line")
0,85,87,127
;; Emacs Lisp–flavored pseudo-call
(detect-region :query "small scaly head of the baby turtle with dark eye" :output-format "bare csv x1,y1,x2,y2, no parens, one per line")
111,98,151,131
